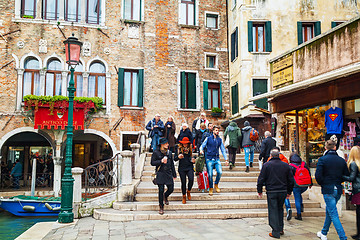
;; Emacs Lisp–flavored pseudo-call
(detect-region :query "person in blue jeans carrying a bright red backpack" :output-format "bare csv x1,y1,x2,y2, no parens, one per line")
290,153,313,220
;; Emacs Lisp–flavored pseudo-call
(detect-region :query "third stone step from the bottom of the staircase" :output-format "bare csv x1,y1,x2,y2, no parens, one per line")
135,191,309,203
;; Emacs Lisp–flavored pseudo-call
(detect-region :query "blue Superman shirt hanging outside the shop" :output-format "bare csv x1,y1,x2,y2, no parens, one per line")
325,107,343,134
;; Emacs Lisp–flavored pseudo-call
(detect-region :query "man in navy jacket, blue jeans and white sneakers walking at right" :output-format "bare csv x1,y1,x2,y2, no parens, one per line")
315,140,349,240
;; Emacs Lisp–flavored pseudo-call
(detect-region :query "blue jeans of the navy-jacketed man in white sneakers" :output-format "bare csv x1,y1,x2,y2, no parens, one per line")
321,189,347,240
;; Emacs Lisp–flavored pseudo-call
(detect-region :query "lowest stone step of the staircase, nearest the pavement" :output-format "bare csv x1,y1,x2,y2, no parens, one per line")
93,206,325,221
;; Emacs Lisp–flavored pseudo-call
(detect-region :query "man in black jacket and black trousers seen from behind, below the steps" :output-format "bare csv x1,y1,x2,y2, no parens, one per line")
257,149,294,238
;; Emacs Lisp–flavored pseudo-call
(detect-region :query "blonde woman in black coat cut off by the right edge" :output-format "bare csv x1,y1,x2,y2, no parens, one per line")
343,146,360,240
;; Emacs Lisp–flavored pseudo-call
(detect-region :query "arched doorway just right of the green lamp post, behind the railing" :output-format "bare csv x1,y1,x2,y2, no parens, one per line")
63,129,116,168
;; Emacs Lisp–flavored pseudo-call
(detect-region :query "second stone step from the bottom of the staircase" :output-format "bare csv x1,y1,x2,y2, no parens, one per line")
113,199,320,211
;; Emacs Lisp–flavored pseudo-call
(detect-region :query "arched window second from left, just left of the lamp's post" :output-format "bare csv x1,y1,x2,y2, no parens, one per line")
45,59,62,96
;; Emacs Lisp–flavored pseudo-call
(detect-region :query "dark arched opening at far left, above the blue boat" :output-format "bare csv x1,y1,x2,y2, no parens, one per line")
0,129,53,189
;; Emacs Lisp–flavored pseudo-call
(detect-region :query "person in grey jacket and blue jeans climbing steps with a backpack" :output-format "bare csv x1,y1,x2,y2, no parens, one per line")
241,121,259,172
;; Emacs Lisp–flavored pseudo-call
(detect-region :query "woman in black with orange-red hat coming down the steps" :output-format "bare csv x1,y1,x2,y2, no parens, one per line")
175,137,195,204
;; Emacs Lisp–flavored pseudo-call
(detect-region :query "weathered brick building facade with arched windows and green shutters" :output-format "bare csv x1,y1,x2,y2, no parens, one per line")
0,0,229,194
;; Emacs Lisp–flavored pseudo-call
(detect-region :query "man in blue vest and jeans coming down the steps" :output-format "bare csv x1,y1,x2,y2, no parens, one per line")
200,126,228,196
